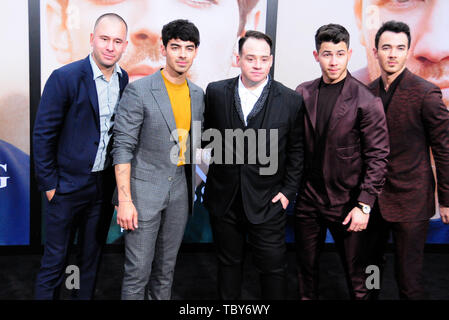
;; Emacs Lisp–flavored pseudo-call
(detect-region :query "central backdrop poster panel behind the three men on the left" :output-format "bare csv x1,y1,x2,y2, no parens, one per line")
41,0,267,243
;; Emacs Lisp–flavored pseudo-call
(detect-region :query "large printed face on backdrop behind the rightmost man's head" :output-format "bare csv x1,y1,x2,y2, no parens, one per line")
354,0,449,106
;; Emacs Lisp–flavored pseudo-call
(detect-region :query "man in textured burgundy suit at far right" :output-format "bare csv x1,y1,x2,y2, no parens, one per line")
368,21,449,299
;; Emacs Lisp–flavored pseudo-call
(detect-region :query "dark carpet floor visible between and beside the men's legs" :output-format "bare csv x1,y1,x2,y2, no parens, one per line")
0,250,449,300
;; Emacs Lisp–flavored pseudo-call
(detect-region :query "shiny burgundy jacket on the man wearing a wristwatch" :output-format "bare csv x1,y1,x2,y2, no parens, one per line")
296,72,389,206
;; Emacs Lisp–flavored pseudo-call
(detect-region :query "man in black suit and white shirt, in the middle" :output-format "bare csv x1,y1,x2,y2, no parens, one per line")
204,31,303,300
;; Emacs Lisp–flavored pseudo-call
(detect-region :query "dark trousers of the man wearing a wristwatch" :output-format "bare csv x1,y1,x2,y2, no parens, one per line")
295,201,371,300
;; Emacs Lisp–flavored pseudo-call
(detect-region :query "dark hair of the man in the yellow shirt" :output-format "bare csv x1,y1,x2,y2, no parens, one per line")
162,19,200,47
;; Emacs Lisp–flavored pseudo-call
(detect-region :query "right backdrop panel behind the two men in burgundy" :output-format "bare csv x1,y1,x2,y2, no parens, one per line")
275,0,449,243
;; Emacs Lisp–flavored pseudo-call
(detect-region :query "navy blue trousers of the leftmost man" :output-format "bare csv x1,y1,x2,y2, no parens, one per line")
35,169,115,300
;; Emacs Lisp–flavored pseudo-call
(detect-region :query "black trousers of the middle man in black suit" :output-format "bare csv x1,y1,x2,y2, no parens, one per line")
210,191,287,300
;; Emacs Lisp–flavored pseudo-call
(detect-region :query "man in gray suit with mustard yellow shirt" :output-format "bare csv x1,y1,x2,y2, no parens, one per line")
112,20,204,300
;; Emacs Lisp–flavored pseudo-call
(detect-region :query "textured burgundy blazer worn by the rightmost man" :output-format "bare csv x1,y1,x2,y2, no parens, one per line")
369,69,449,222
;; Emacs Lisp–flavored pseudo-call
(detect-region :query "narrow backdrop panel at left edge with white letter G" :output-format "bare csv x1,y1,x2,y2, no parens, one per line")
0,1,30,245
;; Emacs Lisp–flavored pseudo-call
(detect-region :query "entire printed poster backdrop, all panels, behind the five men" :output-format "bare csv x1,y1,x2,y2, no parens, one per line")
0,0,449,245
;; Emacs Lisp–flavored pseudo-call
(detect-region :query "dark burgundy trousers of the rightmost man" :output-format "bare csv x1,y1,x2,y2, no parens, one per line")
367,204,429,300
